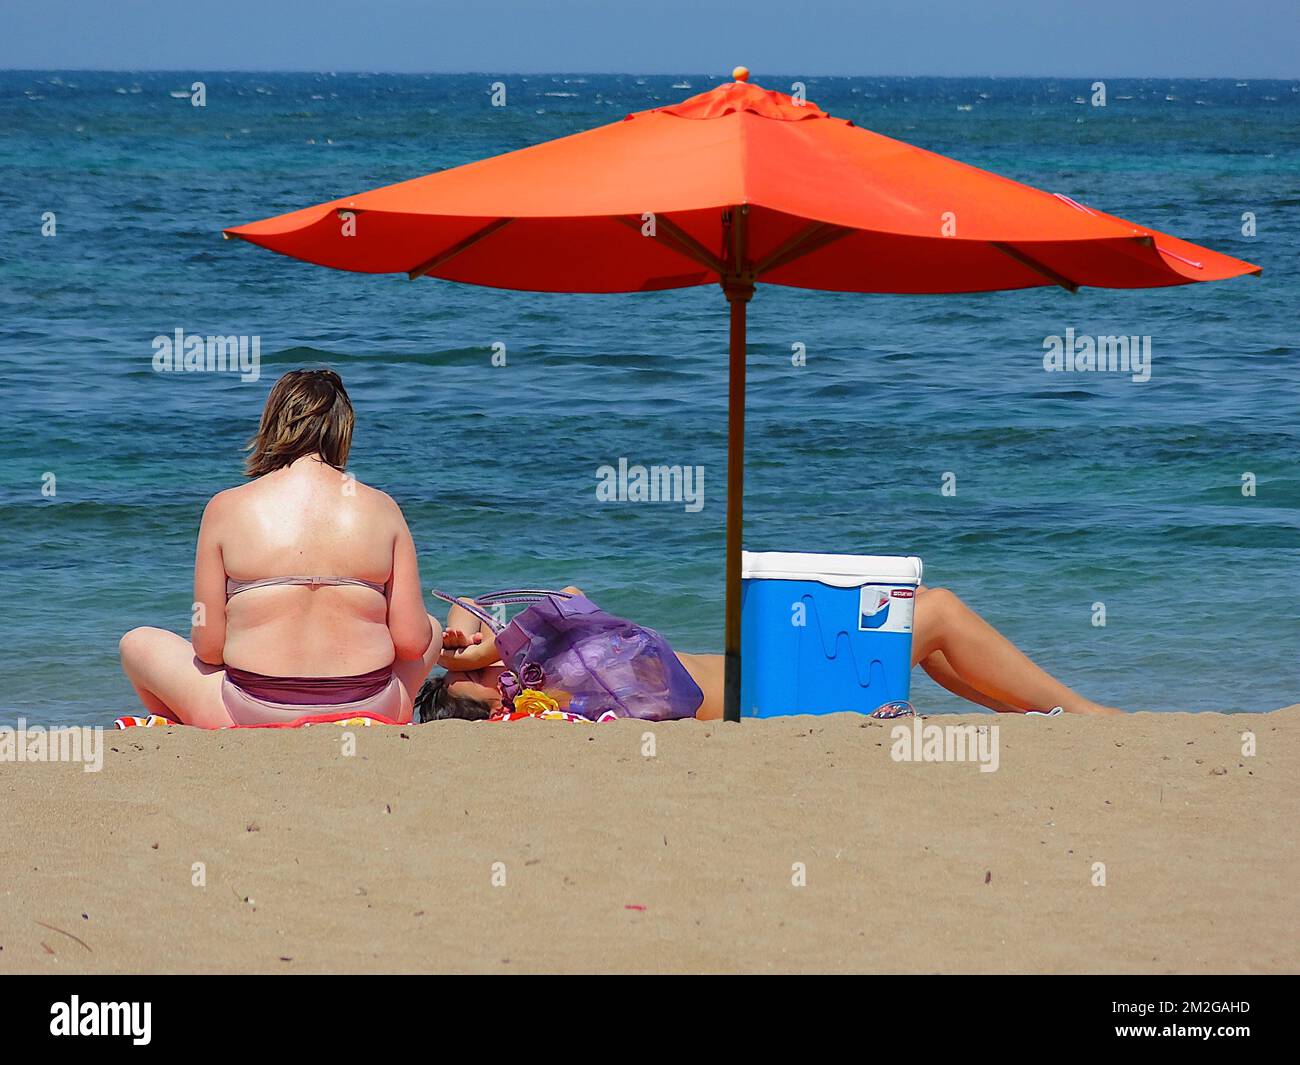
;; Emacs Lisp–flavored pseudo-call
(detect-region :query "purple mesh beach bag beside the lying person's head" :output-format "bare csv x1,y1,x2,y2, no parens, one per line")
434,589,705,722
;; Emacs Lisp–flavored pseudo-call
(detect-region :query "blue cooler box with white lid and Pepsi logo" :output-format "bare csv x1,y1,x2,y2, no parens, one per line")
740,551,920,718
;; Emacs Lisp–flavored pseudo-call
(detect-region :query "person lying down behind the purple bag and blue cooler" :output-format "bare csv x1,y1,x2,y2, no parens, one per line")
416,585,1123,722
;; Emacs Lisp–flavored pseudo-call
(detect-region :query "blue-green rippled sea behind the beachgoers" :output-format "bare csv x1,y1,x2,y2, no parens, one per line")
0,72,1300,724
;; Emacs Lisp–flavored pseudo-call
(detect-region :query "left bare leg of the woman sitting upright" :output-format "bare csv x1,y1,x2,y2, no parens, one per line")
118,628,234,728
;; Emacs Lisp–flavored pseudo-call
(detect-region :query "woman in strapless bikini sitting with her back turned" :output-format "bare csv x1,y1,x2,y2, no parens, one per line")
121,369,442,728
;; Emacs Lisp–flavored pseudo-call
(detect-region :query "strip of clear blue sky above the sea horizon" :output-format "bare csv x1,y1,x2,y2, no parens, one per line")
0,0,1300,78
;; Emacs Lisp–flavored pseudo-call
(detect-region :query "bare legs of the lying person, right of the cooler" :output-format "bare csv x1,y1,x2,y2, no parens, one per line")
911,588,1122,714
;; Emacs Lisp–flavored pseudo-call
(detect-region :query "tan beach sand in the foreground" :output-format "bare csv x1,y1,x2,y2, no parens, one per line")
0,705,1300,973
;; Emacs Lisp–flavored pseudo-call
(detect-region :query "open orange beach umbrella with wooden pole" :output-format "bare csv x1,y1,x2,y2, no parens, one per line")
225,68,1260,719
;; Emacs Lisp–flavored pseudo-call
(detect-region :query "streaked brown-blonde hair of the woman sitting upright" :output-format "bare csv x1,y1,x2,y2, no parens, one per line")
244,369,355,477
